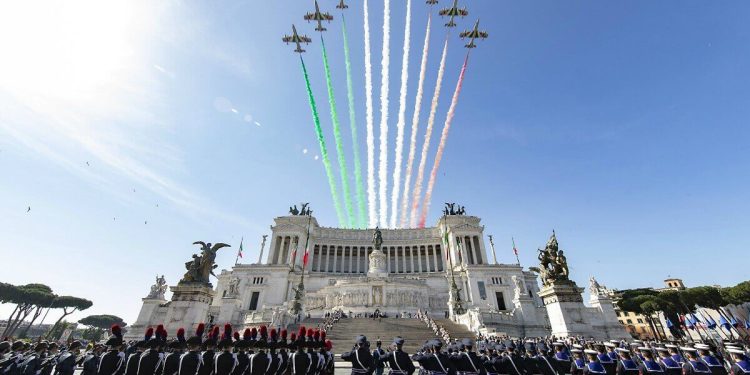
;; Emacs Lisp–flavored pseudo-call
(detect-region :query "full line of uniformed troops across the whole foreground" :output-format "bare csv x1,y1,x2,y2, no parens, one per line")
0,324,750,375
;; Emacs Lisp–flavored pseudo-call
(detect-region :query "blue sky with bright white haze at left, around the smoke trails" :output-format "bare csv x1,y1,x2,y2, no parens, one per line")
0,0,750,322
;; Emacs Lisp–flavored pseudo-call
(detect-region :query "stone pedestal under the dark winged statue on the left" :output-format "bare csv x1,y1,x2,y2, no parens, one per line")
164,283,214,332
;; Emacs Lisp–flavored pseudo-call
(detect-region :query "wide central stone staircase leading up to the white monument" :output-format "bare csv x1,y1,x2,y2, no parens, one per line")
320,318,474,354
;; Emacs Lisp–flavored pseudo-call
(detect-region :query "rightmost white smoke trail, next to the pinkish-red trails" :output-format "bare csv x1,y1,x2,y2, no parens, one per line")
391,0,411,228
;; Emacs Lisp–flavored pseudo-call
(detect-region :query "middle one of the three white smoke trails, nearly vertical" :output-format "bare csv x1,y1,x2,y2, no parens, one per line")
378,0,391,227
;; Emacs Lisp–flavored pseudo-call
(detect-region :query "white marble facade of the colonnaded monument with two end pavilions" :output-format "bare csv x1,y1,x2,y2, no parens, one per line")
131,215,628,336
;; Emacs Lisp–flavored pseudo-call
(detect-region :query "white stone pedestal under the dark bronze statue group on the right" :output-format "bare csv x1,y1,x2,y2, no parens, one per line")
539,281,601,337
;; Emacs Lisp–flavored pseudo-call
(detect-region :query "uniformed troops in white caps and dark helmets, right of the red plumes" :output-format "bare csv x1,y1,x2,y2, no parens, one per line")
341,336,750,375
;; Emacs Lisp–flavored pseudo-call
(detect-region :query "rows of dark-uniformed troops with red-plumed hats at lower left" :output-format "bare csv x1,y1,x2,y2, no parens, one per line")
0,324,334,375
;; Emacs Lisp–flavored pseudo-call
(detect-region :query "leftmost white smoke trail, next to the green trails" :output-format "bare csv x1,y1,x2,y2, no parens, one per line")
364,0,378,228
